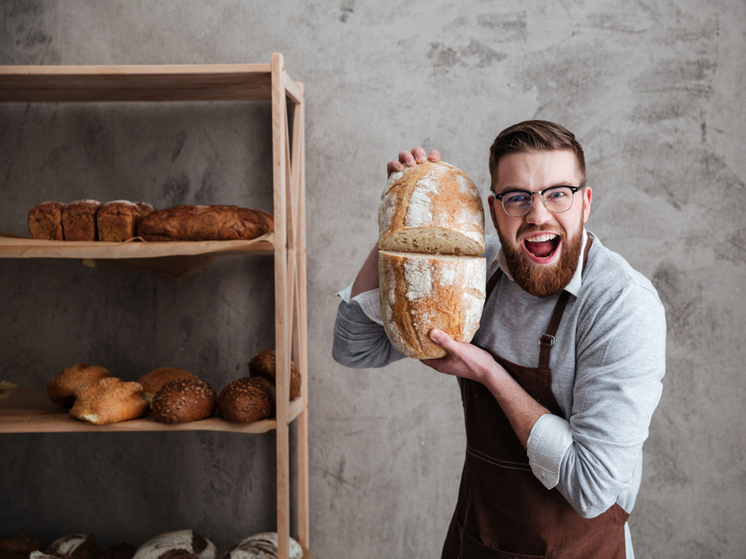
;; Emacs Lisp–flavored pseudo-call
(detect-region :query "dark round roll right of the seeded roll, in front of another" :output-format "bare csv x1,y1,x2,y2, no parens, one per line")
218,377,275,423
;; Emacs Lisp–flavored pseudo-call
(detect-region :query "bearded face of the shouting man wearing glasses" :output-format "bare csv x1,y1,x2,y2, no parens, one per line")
490,150,593,297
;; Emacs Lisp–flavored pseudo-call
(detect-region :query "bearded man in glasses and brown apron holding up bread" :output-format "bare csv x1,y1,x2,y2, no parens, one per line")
333,120,666,559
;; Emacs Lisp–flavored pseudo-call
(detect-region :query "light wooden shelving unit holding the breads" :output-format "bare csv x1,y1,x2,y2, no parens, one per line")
0,53,310,559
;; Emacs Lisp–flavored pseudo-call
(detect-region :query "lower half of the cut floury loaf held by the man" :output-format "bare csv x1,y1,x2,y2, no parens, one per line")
378,251,486,359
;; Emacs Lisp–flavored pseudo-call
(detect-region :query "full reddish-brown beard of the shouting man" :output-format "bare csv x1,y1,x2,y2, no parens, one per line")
497,214,583,297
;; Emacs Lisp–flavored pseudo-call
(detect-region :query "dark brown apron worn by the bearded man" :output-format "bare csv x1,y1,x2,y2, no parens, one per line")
442,235,629,559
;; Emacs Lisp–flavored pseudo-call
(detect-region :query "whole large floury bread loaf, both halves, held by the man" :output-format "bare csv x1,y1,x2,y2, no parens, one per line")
378,161,486,359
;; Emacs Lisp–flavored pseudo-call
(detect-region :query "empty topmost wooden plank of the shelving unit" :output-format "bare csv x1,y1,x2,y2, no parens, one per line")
0,64,271,103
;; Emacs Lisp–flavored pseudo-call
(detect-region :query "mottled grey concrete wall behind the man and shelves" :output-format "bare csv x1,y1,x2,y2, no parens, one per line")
0,0,746,559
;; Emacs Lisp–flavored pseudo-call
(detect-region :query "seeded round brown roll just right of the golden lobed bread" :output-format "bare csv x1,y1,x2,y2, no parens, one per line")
151,379,217,423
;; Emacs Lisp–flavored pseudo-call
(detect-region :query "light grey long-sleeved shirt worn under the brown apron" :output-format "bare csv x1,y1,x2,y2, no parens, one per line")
333,232,666,556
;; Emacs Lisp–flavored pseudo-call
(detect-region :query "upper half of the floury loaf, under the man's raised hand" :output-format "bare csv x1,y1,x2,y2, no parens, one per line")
378,161,484,256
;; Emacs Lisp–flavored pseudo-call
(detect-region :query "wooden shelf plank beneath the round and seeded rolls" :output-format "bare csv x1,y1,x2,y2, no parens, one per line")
0,388,303,434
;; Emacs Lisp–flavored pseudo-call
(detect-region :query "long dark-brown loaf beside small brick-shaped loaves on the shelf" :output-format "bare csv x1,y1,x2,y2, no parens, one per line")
137,204,274,241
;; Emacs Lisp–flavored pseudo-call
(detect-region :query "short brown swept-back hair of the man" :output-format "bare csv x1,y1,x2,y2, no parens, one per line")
490,120,585,186
